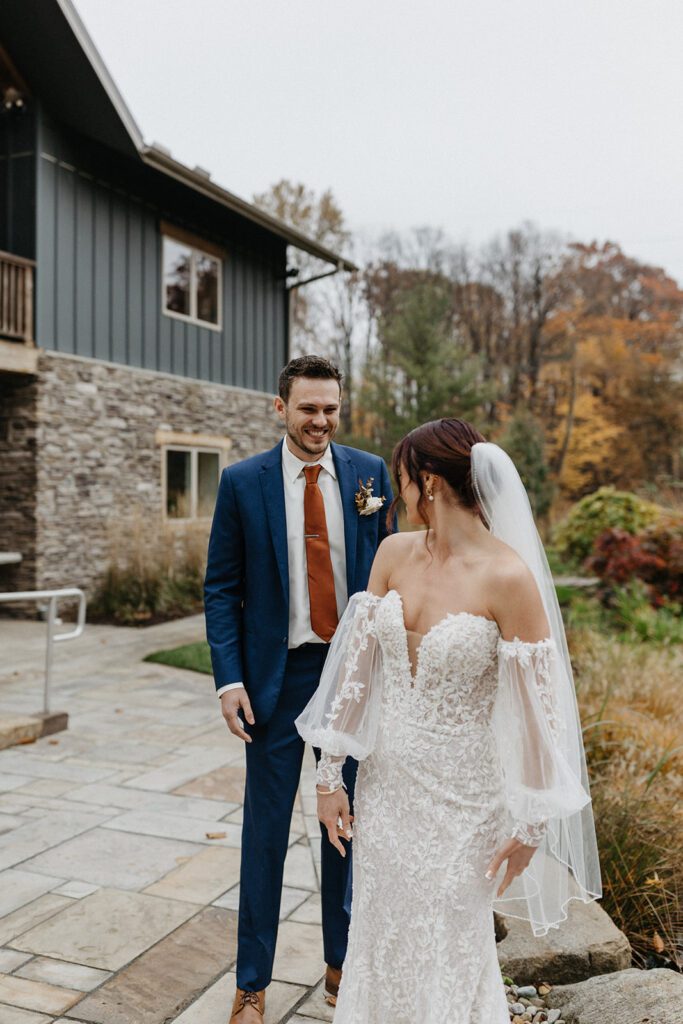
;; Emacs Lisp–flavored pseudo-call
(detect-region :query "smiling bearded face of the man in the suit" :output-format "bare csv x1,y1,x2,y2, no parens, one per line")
275,377,341,462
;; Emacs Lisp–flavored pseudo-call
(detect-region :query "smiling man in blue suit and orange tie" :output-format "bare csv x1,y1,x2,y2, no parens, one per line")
205,355,391,1024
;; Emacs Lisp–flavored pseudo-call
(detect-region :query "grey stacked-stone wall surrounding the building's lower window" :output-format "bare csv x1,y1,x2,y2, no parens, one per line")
26,352,282,593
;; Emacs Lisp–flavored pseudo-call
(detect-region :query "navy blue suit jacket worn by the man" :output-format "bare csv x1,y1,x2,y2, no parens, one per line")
204,441,392,724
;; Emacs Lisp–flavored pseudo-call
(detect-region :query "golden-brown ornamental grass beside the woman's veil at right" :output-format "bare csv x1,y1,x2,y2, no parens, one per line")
569,628,683,970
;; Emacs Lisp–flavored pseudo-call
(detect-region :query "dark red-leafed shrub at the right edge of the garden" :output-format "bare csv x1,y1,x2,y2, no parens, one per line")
586,520,683,607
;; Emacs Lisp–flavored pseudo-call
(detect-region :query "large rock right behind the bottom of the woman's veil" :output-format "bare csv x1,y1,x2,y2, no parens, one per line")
498,900,631,985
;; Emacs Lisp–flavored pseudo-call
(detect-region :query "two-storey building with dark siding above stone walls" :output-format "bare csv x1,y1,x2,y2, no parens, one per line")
0,0,353,590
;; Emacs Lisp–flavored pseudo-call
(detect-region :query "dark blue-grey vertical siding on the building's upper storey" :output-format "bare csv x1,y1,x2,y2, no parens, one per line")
36,115,287,391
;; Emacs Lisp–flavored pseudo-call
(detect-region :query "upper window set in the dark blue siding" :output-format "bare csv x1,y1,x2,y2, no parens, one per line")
162,234,222,329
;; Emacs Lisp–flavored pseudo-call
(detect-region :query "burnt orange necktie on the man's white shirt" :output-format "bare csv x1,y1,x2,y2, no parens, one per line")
303,466,339,643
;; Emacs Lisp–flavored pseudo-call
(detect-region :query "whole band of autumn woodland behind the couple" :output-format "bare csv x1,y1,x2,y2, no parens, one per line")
256,181,683,510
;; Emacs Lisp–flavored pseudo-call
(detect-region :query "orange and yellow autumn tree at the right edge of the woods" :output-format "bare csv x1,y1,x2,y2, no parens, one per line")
541,244,683,498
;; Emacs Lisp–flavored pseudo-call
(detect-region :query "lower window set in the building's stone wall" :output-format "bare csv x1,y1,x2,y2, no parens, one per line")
164,447,222,519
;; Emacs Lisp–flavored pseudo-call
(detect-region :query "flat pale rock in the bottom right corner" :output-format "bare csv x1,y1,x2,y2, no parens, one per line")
546,968,683,1024
